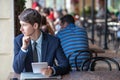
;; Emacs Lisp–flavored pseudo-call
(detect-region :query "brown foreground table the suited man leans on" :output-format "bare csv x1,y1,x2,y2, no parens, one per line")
7,71,120,80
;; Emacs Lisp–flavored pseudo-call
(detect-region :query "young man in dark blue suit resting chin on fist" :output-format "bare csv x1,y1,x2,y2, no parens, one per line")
13,9,70,76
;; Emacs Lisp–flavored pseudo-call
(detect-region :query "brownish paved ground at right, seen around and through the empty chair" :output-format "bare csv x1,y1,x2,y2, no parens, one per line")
88,31,120,71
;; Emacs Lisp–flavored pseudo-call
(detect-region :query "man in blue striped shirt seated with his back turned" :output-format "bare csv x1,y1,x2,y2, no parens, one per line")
57,15,89,70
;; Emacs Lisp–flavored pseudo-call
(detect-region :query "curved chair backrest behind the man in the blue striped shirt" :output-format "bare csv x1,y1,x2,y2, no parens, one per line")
68,50,93,71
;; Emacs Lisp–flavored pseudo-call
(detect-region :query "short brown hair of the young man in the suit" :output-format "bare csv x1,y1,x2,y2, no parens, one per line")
18,8,41,27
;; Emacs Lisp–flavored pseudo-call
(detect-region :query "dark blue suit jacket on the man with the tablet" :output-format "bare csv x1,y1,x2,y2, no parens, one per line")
13,33,70,75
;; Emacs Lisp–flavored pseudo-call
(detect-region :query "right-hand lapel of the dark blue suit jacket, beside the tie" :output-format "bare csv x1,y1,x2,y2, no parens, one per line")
41,33,48,62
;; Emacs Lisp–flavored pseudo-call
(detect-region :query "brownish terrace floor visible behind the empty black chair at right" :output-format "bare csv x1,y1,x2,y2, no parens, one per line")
88,30,120,70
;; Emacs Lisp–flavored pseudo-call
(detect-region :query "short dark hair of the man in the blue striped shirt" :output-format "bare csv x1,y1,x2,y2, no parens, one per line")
60,14,75,24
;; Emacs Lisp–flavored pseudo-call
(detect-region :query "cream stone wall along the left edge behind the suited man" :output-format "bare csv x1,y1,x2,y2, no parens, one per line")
0,0,14,80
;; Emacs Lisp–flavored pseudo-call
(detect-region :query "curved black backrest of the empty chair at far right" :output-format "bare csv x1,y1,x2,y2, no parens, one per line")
81,57,120,71
